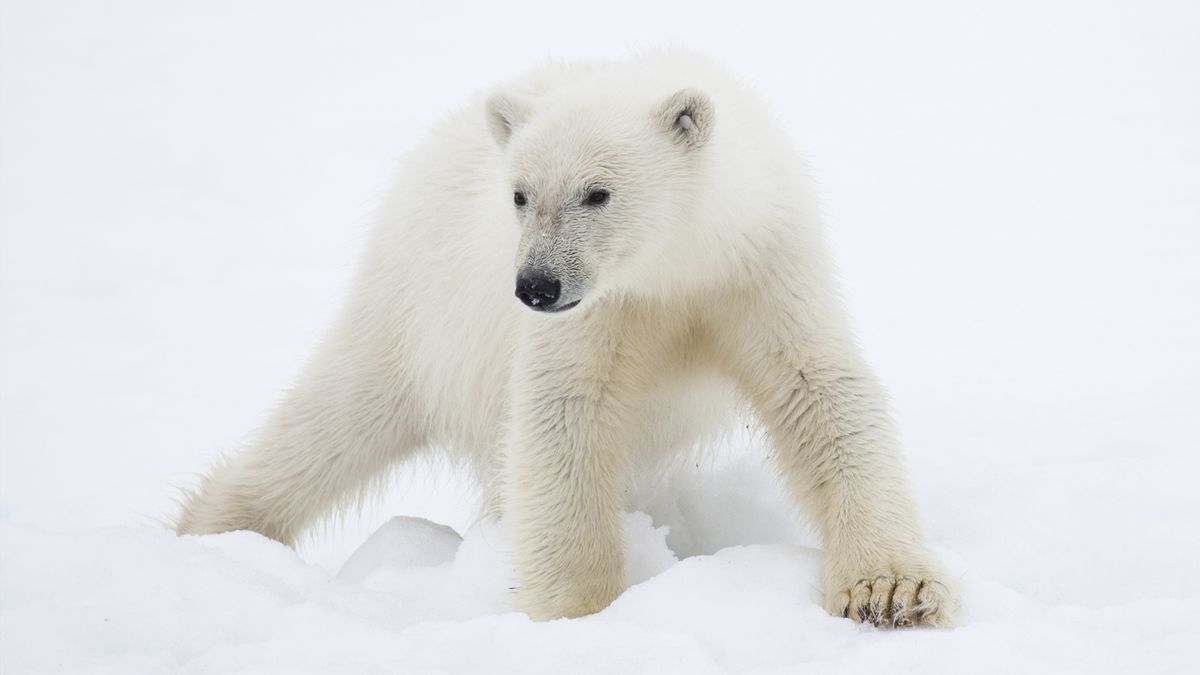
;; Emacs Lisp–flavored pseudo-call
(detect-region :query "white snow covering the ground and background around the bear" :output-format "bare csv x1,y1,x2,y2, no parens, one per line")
0,0,1200,674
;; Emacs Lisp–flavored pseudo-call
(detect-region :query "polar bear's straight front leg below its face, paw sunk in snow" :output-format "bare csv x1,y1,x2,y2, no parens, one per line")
504,317,625,620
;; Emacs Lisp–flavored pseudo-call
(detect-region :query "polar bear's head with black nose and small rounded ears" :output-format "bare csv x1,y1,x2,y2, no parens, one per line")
486,84,714,312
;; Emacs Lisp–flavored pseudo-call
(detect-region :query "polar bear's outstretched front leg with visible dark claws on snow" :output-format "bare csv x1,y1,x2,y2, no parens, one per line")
731,294,955,627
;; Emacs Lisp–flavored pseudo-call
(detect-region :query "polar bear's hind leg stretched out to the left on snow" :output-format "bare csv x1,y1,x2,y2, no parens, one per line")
175,330,425,545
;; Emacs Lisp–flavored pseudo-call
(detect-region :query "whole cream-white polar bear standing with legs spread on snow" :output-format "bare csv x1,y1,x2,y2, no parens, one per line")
176,53,955,626
